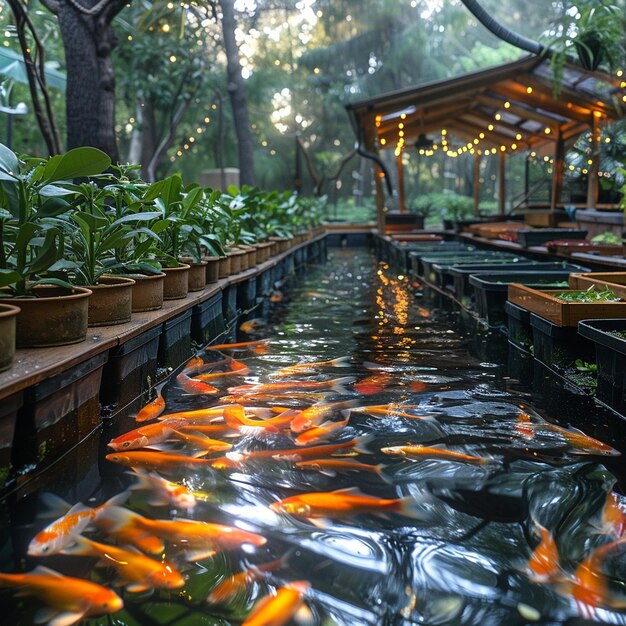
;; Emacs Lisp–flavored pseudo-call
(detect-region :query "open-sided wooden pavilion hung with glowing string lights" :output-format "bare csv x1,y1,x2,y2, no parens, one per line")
346,56,626,229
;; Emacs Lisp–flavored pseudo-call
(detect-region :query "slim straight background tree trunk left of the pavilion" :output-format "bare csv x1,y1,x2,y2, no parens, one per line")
220,0,255,185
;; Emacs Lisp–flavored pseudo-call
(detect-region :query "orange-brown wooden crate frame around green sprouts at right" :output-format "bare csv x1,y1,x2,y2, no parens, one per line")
509,283,626,326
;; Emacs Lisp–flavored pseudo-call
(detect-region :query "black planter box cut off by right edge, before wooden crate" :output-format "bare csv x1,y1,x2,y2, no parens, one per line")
578,319,626,415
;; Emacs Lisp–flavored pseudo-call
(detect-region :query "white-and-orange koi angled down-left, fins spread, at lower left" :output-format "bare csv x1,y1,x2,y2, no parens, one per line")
28,491,129,556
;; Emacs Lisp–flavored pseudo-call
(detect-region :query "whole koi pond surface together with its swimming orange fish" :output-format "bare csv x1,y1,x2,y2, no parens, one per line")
0,250,626,626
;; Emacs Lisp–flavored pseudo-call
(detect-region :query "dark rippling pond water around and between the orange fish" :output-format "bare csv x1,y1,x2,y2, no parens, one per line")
0,250,626,626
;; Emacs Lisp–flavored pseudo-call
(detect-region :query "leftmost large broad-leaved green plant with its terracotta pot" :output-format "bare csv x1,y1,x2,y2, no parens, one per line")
0,145,110,347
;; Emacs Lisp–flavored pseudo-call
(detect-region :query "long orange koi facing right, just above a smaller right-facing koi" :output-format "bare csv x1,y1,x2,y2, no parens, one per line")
100,507,267,561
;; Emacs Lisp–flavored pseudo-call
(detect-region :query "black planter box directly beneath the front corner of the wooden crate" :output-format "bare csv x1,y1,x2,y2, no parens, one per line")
530,313,595,373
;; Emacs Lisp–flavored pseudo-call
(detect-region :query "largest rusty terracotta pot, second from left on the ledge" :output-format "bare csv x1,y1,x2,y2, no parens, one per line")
0,285,91,348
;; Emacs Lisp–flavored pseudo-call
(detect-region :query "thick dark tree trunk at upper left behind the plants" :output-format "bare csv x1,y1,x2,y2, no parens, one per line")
42,0,126,163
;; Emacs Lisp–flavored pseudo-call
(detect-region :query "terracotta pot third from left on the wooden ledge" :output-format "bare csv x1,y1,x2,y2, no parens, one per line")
88,276,135,326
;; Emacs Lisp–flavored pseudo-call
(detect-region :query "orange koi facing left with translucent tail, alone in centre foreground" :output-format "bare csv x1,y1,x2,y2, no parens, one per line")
270,487,424,519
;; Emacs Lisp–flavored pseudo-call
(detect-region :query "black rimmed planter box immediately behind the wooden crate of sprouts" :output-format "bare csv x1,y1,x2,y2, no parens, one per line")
468,263,581,326
